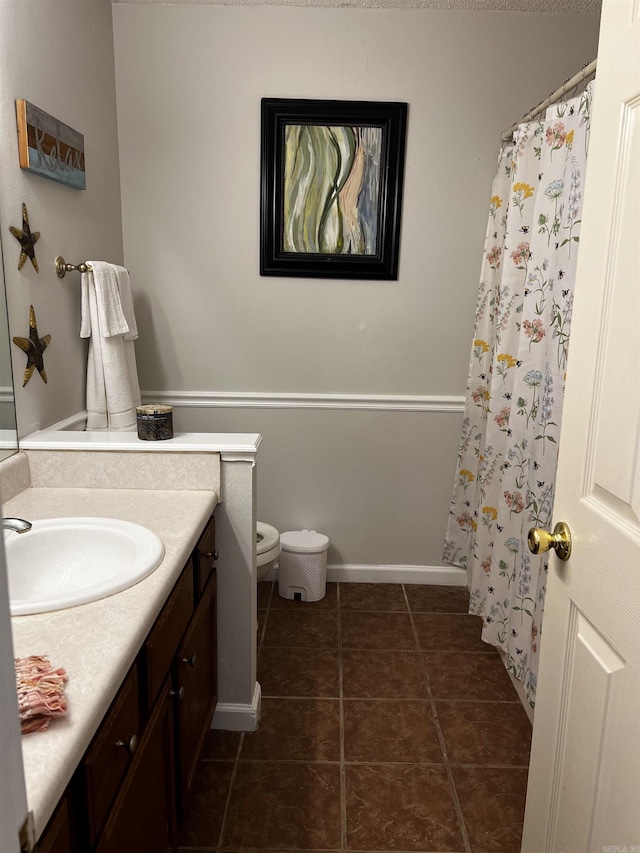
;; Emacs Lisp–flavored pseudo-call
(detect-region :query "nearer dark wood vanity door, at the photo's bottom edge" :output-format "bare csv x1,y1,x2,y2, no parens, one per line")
96,679,176,853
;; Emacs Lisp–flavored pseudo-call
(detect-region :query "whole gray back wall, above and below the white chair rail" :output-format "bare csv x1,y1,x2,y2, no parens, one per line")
113,4,598,566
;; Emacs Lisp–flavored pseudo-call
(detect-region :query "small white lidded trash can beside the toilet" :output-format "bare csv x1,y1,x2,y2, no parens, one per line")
278,530,329,601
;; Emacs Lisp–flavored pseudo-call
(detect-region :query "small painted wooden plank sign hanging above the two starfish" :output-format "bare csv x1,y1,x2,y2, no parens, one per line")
16,99,87,190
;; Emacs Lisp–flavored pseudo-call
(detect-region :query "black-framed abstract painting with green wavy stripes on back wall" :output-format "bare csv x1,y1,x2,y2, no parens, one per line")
260,98,408,280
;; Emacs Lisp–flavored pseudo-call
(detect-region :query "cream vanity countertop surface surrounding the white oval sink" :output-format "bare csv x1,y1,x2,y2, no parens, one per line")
3,482,218,837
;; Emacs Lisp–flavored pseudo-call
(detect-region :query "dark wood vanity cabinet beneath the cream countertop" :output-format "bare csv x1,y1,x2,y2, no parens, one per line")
37,518,217,853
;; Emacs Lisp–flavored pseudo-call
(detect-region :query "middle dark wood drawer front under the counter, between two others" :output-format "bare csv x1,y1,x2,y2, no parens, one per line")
143,560,194,709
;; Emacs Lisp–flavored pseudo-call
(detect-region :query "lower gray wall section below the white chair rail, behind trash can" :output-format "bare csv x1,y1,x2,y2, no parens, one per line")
181,408,460,566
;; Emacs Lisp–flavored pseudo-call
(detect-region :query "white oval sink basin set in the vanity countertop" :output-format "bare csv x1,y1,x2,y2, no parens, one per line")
4,518,164,616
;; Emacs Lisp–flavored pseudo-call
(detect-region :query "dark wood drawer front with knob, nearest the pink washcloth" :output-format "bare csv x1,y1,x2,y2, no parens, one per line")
84,664,141,844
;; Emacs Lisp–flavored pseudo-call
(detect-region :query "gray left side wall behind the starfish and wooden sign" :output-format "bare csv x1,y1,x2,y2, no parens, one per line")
0,0,122,435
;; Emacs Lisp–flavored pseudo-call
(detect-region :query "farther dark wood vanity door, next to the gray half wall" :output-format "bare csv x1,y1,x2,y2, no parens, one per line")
174,573,217,815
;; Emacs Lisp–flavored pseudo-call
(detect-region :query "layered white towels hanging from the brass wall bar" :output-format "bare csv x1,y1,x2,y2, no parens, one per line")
80,261,140,430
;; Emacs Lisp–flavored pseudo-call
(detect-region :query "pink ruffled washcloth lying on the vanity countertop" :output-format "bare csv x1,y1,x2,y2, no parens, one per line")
14,655,67,734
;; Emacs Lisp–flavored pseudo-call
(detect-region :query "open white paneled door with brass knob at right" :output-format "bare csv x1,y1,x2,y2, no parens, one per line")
522,0,640,853
